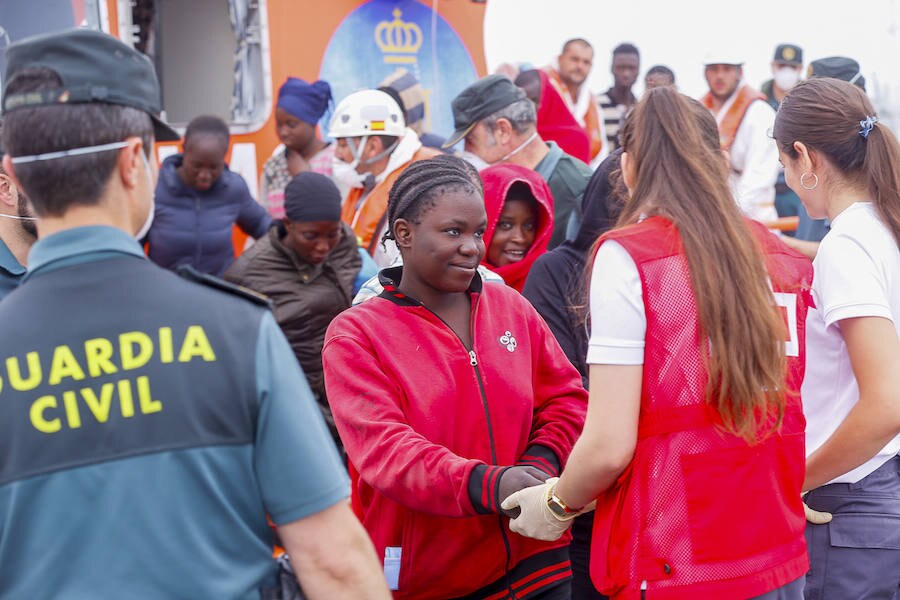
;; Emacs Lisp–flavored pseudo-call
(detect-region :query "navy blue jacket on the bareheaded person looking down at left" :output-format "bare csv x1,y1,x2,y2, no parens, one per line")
147,154,271,276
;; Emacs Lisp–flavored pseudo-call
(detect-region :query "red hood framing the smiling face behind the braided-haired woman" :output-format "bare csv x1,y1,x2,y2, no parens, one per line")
480,163,553,292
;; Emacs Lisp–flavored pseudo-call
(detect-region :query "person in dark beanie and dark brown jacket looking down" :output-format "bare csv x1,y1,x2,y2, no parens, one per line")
225,172,362,447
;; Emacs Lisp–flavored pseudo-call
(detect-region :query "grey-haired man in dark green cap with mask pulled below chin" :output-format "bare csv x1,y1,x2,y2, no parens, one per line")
444,75,593,249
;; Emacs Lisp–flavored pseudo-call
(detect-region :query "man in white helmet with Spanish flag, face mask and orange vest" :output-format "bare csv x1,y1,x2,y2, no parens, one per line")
328,90,440,267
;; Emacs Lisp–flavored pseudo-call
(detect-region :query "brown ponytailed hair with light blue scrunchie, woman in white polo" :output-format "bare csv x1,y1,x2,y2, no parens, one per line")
774,77,900,244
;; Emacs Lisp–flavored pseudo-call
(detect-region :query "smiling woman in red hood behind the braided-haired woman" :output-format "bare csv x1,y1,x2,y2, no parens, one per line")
480,164,553,292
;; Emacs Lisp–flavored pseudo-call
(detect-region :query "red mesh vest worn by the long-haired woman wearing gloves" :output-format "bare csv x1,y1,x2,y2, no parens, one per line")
591,217,812,599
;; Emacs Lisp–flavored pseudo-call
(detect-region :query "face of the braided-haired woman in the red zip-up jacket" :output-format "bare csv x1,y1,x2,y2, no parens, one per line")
400,191,487,293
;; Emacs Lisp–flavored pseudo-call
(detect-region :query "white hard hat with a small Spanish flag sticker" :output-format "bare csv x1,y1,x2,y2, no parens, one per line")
328,90,406,138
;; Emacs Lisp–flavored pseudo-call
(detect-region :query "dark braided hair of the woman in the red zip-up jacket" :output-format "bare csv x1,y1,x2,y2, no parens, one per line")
381,154,484,243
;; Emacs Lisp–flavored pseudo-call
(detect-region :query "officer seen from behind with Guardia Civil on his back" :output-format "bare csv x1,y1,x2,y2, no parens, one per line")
0,30,389,599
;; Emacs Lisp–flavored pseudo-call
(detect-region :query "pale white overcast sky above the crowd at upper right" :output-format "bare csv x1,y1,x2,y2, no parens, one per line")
485,0,900,126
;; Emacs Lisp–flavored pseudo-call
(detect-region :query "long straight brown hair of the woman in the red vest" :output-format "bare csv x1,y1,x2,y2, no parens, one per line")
618,87,786,443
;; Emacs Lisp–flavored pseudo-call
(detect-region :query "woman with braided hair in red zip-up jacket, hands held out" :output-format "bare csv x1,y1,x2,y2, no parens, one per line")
323,156,586,600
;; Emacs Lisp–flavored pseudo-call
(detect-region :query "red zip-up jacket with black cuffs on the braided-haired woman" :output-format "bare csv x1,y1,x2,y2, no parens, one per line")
323,267,587,599
